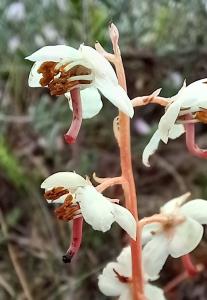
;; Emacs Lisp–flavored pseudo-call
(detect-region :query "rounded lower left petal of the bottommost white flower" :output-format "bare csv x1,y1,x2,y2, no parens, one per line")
98,263,124,297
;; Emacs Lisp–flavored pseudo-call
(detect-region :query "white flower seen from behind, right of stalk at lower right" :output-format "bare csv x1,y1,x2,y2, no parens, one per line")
142,193,207,276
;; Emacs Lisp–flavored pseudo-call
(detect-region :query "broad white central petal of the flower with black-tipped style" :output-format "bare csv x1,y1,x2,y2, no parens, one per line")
76,186,115,232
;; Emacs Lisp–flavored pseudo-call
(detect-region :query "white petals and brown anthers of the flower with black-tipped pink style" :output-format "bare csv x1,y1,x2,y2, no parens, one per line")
41,172,136,239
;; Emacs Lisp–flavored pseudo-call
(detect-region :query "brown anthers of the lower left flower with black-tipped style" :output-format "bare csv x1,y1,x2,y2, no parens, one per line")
44,187,81,222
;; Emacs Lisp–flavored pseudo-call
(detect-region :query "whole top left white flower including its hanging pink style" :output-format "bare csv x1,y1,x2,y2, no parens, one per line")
26,45,134,143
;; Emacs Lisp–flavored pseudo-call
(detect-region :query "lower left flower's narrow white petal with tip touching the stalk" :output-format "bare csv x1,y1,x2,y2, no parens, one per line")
112,203,137,240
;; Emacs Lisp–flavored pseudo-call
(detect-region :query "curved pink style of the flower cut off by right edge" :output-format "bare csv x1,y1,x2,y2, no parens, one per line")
184,114,207,158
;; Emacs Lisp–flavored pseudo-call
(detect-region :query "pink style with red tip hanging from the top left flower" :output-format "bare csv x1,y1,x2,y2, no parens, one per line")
64,88,82,144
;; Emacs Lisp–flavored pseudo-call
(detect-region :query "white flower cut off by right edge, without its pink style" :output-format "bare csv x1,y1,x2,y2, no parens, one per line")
142,78,207,166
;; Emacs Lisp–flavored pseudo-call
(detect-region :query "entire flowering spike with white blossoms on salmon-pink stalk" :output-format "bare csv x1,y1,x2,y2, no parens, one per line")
27,24,207,300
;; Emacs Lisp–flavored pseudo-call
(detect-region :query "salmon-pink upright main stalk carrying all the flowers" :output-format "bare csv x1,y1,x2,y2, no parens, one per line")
109,25,144,300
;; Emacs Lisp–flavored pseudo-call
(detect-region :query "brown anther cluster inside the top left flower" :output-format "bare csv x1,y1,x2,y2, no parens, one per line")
38,61,92,96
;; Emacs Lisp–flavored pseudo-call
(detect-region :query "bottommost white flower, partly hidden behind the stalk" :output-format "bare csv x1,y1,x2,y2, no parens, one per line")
98,247,165,300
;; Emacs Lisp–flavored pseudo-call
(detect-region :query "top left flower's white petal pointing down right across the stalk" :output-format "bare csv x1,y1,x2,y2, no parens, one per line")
95,81,134,118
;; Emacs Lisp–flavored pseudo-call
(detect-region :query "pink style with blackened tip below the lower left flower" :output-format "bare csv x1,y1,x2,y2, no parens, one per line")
63,217,83,263
